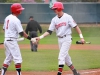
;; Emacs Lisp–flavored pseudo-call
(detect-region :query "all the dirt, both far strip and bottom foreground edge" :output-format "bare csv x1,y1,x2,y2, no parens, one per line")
0,44,100,75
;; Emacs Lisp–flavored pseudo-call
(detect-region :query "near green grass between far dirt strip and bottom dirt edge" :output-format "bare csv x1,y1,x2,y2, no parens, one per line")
0,50,100,71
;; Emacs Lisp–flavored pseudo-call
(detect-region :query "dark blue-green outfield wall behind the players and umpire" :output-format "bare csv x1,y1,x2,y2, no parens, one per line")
0,2,100,23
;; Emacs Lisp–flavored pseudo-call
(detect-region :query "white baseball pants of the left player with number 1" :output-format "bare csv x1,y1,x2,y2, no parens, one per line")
4,39,22,65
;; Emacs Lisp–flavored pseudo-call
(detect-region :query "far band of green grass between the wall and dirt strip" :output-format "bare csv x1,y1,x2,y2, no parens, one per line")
0,25,100,44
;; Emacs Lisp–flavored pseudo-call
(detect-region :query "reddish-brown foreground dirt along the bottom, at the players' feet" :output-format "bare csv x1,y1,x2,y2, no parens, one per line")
0,69,100,75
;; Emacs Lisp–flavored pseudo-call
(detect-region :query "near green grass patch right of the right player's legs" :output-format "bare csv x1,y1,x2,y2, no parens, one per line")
71,50,100,69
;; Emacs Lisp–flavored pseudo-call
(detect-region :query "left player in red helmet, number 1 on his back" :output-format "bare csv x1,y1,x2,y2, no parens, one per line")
1,3,31,75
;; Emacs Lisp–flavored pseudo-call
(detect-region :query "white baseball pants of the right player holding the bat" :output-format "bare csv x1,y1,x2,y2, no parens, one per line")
58,35,72,66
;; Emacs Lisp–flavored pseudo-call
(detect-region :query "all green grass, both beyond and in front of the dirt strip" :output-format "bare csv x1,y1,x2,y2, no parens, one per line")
0,25,100,71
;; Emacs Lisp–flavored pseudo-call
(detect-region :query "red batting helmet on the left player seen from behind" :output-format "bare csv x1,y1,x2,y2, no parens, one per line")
11,3,24,14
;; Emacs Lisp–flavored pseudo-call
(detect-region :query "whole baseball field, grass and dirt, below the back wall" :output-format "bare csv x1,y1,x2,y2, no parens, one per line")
0,24,100,75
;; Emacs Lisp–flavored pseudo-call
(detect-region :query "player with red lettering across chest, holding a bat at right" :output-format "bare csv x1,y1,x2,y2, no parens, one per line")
36,2,85,75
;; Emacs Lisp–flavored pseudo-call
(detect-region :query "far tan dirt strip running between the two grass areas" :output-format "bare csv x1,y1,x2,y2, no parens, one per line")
0,44,100,50
